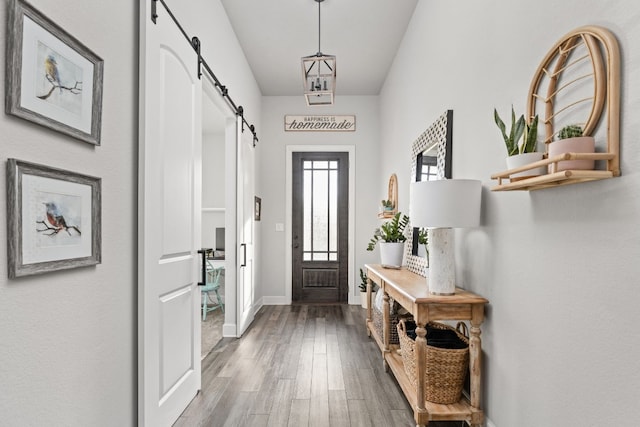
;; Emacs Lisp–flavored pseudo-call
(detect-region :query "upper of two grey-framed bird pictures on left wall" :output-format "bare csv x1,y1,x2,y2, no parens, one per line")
5,0,104,145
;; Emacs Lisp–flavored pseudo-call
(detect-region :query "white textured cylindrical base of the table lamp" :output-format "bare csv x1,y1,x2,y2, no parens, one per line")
428,228,456,295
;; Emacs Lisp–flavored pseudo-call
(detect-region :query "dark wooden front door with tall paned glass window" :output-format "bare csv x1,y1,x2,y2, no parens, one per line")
292,152,349,303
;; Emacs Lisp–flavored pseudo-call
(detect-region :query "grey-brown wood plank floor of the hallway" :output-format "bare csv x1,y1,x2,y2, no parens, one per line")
174,305,464,427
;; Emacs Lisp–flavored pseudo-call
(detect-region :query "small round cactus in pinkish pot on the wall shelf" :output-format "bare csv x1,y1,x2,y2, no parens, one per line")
547,124,596,171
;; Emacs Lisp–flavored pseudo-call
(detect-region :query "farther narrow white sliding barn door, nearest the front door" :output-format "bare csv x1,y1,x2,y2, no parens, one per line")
236,119,255,337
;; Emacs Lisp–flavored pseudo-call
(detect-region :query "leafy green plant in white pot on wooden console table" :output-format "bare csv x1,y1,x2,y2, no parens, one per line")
367,212,409,268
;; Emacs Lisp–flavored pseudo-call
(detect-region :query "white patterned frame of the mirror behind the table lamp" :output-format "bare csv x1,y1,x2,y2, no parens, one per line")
405,110,453,277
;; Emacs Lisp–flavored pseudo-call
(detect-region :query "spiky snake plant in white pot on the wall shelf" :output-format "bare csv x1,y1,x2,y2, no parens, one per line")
493,106,546,181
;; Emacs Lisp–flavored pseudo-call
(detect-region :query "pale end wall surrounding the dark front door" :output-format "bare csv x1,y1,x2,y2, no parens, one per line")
258,96,382,302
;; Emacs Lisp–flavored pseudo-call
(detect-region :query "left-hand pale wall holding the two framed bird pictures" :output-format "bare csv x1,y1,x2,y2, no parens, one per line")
0,0,261,426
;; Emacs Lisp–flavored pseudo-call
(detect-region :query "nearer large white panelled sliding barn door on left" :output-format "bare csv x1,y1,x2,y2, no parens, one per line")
138,1,202,427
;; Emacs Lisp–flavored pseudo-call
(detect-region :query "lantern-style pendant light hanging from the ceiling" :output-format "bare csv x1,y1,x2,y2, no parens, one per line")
302,0,336,106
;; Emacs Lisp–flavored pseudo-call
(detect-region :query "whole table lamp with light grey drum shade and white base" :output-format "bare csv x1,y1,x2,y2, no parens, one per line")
409,179,482,295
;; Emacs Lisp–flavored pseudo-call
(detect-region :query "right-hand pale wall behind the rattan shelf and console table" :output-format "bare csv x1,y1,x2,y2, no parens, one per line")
378,0,640,427
